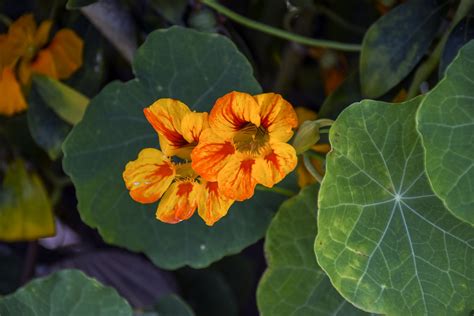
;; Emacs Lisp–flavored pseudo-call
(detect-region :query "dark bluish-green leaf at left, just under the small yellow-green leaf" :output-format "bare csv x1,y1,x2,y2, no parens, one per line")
26,85,71,160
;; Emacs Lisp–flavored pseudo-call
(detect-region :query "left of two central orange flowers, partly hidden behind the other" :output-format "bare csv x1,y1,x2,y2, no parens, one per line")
123,99,234,226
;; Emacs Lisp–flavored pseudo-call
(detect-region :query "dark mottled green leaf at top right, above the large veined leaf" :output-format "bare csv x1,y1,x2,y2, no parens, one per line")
360,0,447,98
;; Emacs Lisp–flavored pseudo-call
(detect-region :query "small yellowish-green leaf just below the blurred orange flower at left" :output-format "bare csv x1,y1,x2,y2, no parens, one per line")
33,75,89,125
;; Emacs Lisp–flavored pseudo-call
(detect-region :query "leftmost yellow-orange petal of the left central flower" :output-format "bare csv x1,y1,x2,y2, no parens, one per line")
123,148,176,203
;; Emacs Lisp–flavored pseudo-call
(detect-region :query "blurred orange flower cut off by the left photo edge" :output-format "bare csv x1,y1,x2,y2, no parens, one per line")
0,14,83,116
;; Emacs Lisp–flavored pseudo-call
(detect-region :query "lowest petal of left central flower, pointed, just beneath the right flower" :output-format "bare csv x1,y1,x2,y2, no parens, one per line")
198,179,234,226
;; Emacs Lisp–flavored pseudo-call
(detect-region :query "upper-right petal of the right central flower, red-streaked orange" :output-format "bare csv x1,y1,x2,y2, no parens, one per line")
255,93,298,142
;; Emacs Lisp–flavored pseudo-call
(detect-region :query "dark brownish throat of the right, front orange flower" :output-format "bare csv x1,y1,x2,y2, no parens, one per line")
234,123,269,154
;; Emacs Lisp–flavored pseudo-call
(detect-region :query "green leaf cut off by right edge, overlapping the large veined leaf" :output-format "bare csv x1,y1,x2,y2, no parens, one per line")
417,41,474,225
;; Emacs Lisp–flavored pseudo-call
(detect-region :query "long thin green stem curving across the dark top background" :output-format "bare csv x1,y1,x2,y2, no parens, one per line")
202,0,361,52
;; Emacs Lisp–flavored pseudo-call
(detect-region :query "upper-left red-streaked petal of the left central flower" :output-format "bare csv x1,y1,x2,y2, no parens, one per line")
143,99,191,159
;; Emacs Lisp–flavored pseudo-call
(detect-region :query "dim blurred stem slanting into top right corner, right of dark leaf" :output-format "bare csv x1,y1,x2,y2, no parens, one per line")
407,0,474,99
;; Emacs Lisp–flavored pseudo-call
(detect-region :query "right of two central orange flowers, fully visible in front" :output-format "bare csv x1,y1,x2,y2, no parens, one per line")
191,91,298,201
